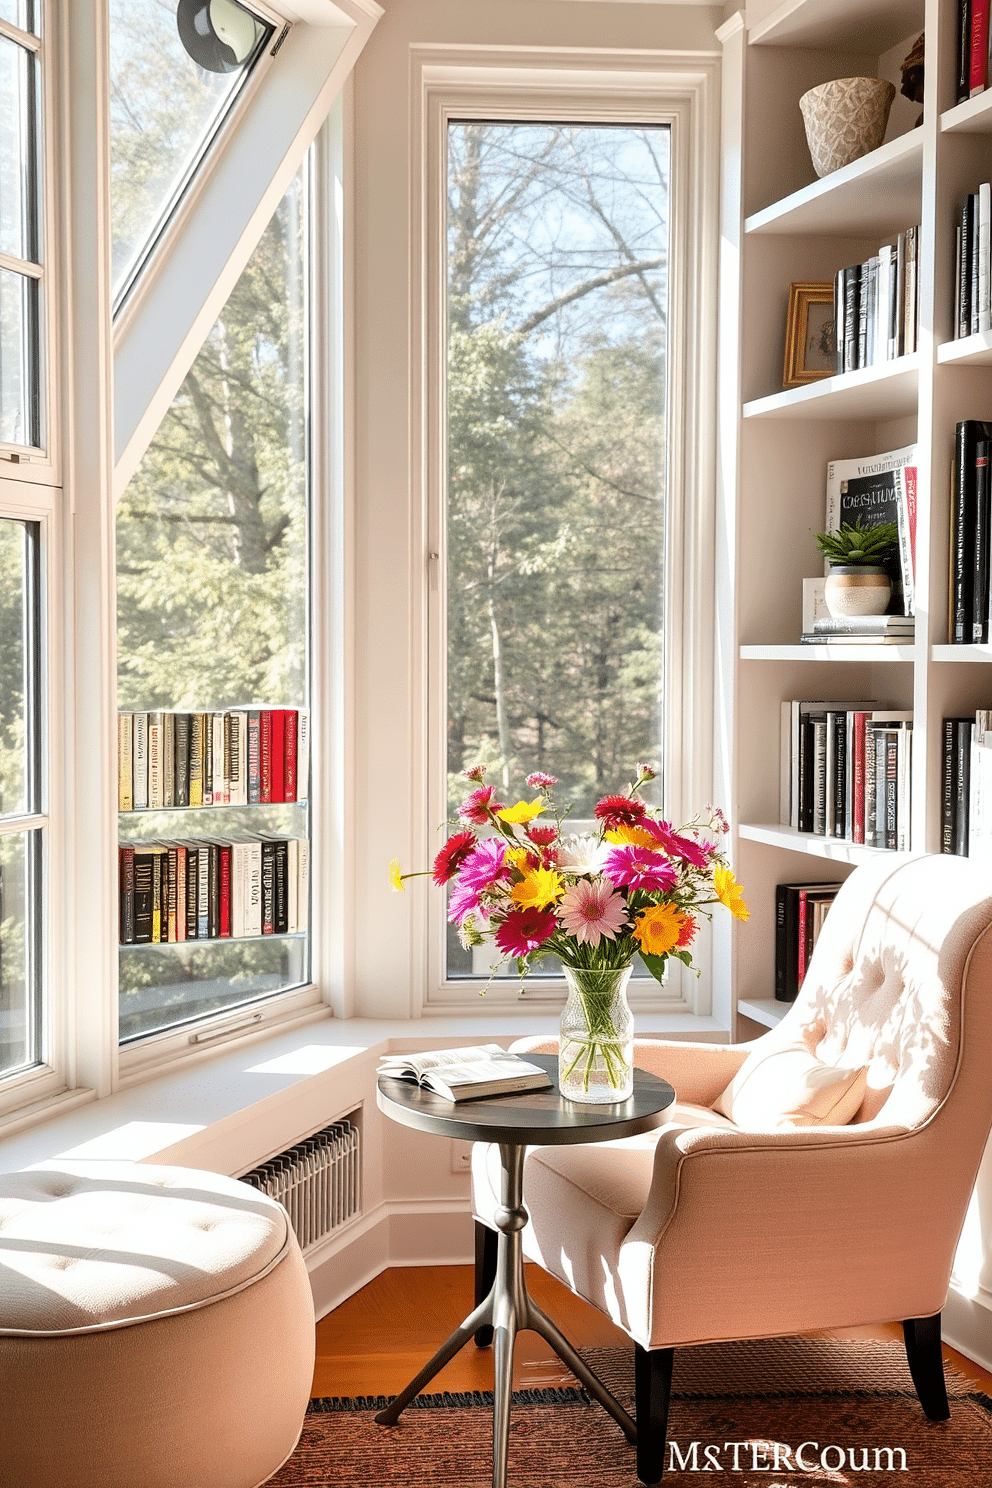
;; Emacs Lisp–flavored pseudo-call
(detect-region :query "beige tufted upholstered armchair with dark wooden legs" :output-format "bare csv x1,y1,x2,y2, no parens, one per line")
473,857,992,1484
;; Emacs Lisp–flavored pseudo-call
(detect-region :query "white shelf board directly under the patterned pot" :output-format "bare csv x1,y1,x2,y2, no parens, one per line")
744,129,924,237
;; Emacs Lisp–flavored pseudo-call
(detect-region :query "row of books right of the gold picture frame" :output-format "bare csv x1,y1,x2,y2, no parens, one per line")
833,228,919,372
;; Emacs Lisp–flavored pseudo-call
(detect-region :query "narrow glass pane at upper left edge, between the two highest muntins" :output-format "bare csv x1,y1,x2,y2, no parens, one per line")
0,37,39,262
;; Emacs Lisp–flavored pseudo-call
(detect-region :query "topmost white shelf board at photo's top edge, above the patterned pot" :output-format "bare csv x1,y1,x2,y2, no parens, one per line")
748,0,924,55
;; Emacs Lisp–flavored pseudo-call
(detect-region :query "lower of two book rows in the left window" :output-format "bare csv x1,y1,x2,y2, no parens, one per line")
117,838,309,945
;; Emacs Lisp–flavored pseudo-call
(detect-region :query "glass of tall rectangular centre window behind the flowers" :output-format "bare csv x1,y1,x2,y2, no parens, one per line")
446,124,669,975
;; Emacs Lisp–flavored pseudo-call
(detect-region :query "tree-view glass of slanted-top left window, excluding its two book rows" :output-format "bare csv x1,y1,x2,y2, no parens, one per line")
117,173,309,1037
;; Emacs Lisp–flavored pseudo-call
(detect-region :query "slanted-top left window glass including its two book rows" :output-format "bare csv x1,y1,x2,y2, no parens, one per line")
117,167,311,1042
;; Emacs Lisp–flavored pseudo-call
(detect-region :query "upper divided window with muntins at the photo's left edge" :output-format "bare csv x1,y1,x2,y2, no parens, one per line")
0,0,46,449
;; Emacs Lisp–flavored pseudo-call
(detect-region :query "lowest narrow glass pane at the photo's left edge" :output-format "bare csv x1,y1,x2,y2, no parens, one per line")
0,832,42,1076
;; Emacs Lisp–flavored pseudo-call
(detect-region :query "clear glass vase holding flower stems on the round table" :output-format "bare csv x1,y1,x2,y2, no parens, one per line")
558,966,634,1106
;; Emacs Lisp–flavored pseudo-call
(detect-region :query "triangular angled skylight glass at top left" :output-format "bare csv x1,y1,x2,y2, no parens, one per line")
110,0,275,308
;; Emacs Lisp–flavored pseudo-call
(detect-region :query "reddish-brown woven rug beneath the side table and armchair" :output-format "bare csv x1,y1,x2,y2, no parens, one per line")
271,1338,992,1488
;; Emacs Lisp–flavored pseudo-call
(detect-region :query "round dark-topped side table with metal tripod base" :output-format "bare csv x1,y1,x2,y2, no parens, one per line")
376,1054,675,1488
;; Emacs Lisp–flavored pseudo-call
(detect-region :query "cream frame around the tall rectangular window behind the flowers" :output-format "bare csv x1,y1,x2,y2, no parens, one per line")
412,48,718,1015
